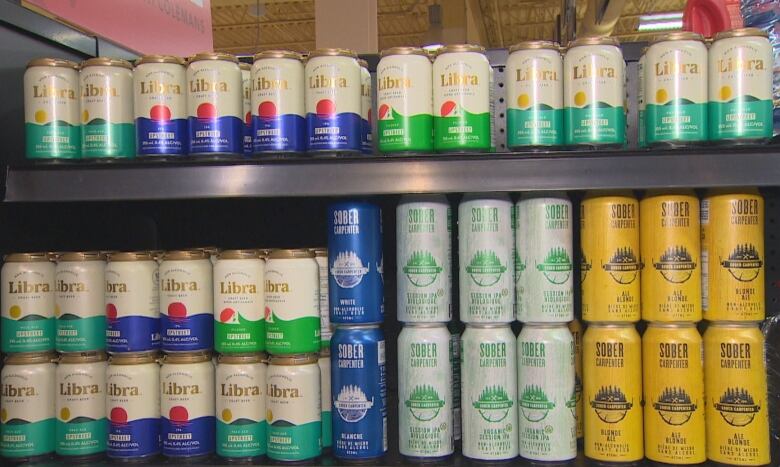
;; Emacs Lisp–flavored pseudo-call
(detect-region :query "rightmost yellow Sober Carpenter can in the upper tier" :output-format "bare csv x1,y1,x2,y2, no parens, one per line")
701,189,765,321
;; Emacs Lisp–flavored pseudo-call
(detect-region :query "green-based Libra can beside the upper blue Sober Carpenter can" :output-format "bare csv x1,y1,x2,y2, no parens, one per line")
265,250,321,355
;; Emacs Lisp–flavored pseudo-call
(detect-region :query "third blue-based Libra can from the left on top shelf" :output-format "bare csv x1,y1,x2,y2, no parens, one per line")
251,50,306,154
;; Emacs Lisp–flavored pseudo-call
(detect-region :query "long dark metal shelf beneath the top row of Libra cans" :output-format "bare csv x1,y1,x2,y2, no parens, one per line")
4,145,780,202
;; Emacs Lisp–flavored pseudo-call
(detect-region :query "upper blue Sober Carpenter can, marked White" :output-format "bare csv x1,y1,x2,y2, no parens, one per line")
328,201,385,324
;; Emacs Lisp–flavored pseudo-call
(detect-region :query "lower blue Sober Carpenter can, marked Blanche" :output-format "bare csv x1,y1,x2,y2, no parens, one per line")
330,325,387,460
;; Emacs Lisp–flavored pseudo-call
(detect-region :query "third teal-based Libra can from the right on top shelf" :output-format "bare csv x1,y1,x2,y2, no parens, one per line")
563,37,626,148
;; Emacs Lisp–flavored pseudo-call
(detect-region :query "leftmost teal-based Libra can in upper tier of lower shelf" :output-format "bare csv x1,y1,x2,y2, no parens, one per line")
0,253,55,353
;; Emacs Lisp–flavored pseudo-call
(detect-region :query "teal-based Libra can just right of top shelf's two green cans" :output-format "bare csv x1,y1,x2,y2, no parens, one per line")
505,41,564,148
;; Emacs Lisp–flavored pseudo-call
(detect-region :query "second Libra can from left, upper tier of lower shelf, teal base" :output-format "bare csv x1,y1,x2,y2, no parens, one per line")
54,251,106,352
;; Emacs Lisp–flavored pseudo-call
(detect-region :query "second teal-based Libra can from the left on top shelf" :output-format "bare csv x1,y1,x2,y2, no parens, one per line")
80,57,135,159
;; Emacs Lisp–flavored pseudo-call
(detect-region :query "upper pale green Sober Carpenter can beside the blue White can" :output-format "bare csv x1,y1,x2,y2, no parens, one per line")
395,195,452,323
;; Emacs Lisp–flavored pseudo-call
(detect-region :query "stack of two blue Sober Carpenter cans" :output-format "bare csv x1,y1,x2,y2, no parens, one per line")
328,200,388,460
